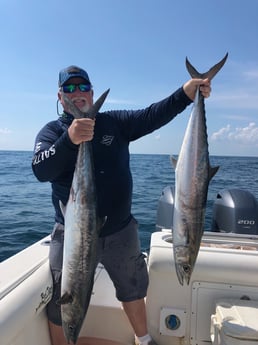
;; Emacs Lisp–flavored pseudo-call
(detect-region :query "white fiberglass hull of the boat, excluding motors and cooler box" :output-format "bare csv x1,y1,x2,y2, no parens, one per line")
0,230,258,345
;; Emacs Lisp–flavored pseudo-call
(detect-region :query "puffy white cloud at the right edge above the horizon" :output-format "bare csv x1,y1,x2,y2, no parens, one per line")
211,122,258,147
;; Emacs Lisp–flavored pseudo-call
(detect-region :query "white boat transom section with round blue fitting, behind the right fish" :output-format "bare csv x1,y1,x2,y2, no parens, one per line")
146,229,258,345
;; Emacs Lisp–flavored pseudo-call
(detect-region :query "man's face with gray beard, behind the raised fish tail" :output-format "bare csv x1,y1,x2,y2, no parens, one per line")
58,78,93,112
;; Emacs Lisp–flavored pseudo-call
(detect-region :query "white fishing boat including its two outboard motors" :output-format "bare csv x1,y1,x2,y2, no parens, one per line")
0,187,258,345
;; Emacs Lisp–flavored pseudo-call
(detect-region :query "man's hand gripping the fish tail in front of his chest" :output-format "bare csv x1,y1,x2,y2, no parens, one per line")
68,118,95,145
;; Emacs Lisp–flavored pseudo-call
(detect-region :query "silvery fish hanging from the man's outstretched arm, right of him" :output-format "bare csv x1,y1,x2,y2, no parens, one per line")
171,53,228,285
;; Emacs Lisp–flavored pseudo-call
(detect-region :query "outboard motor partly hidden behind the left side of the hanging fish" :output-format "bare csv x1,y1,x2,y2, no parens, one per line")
156,186,175,231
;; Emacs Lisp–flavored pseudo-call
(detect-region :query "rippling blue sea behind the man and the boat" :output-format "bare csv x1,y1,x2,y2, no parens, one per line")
0,151,258,262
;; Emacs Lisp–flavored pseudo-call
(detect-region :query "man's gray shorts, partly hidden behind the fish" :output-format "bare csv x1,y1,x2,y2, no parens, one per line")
47,218,149,325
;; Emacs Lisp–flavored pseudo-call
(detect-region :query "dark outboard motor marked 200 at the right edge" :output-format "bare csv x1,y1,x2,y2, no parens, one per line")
211,189,258,235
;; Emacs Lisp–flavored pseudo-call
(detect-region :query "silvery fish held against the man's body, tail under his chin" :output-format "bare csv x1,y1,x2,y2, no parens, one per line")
58,89,109,344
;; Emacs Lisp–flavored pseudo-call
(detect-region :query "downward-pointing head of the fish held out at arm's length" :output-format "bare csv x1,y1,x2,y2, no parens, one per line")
174,246,195,285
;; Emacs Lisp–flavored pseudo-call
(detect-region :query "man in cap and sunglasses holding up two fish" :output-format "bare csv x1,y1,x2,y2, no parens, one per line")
32,66,211,345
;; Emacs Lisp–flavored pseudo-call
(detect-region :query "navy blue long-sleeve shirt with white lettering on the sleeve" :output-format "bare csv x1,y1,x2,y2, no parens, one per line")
32,88,191,236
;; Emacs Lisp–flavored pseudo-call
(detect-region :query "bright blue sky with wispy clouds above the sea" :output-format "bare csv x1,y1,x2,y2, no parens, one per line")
0,0,258,156
